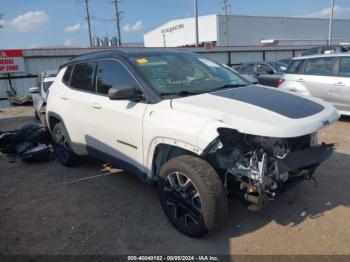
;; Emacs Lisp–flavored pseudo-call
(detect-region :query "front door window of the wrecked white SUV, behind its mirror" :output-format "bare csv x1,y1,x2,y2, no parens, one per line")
96,60,137,94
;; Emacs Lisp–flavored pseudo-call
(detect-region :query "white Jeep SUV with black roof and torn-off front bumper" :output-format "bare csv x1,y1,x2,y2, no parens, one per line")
47,50,339,237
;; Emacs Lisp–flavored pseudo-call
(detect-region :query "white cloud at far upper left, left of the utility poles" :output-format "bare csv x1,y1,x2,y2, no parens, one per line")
3,11,49,32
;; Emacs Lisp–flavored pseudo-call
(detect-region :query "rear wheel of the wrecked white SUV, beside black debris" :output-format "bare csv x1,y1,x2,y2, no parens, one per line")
52,123,77,166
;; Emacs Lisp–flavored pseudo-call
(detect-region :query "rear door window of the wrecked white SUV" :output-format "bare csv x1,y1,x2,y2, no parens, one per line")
70,62,96,92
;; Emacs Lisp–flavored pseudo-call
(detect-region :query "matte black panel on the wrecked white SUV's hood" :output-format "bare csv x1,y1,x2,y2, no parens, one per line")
211,86,324,119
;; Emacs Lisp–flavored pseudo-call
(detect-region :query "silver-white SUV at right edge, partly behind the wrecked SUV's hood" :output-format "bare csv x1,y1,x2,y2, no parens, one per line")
279,53,350,115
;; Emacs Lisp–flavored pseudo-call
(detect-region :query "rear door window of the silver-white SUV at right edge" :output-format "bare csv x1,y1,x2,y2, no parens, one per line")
305,57,336,76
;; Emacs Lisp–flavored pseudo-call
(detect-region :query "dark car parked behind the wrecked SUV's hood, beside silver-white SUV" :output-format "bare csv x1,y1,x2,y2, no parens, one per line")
233,61,288,87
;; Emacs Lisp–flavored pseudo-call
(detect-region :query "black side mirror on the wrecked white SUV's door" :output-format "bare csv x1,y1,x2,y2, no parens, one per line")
108,85,144,101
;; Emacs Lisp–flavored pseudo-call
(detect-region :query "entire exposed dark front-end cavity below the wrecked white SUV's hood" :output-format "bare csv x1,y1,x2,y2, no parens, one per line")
207,128,334,210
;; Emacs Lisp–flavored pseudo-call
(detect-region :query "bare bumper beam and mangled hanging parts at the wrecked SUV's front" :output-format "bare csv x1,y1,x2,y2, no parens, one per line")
224,144,334,210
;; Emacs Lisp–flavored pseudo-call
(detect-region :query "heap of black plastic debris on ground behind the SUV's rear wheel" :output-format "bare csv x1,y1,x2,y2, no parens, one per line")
0,123,53,162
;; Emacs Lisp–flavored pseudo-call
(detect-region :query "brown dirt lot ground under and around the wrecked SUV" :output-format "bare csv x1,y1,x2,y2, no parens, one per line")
0,107,350,255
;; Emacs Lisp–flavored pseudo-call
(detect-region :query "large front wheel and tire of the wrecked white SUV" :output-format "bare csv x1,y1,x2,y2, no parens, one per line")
158,155,228,237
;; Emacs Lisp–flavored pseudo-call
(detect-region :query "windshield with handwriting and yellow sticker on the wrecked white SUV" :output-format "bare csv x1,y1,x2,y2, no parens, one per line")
130,54,248,96
